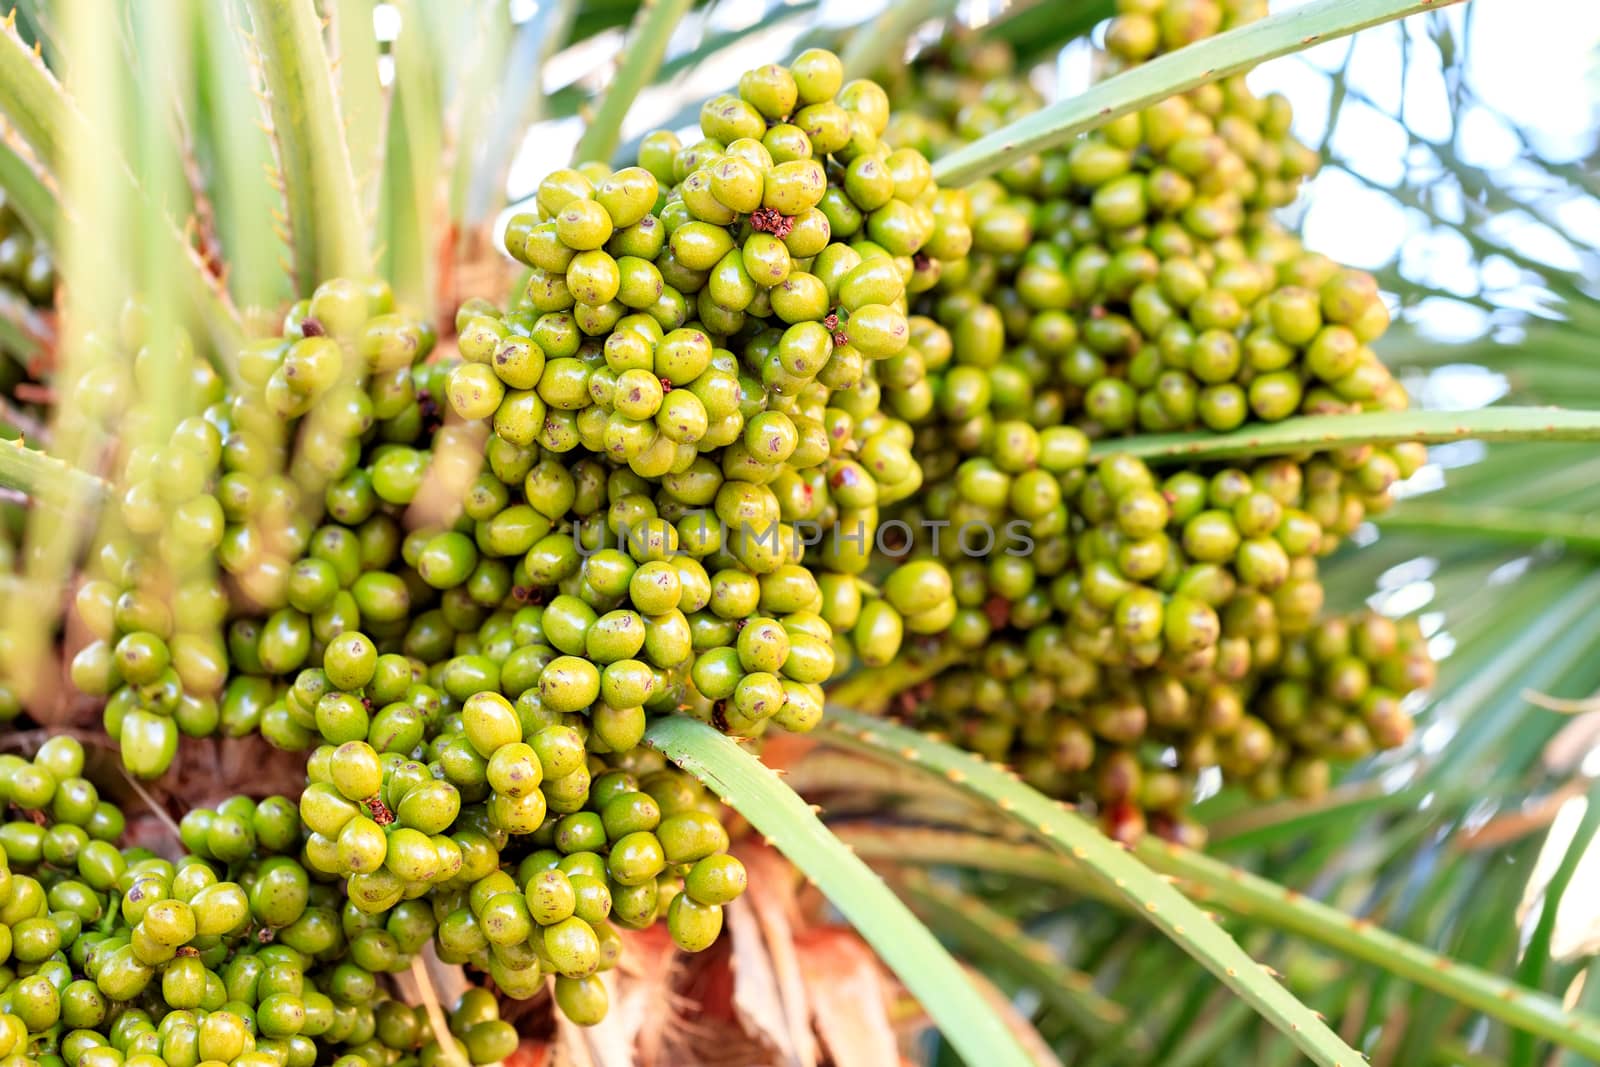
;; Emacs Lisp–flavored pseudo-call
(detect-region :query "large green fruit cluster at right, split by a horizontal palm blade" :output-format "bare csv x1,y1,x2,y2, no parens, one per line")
864,0,1432,840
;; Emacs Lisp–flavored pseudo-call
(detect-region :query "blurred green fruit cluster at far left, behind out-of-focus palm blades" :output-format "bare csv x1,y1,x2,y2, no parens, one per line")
70,273,432,777
